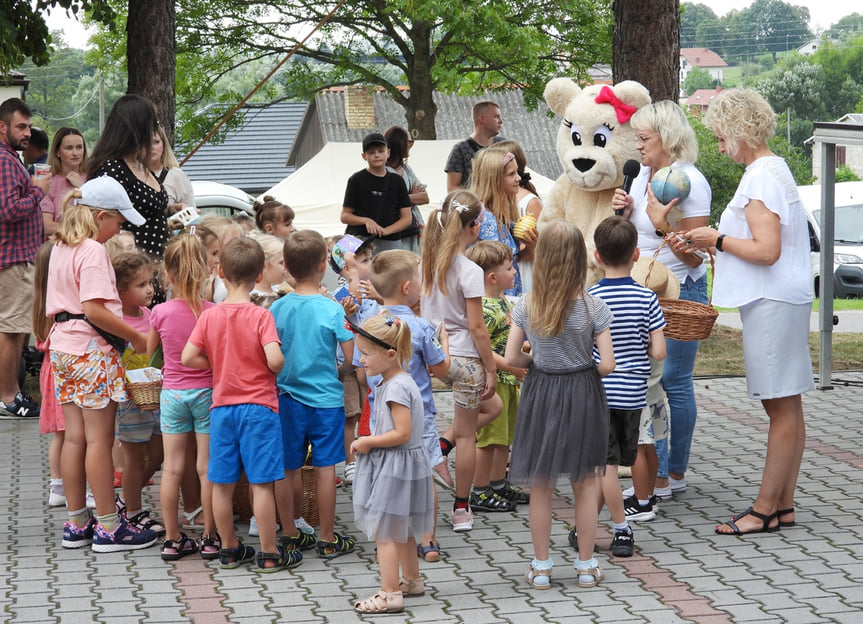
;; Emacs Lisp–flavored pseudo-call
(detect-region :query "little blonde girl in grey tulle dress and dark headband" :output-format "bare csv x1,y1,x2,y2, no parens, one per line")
352,310,434,613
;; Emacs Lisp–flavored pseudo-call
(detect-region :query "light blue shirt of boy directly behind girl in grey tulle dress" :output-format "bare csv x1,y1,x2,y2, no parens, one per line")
354,306,446,431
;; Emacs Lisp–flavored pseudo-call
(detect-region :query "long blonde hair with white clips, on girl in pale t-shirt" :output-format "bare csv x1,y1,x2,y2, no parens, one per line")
422,189,483,296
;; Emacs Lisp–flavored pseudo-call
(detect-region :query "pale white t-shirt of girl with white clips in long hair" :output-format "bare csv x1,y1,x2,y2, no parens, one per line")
422,254,485,358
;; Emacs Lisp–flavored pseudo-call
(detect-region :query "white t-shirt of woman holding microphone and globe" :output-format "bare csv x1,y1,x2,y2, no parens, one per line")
629,162,713,284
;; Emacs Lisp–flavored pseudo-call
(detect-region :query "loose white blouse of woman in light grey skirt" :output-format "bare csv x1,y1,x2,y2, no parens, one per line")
713,156,812,308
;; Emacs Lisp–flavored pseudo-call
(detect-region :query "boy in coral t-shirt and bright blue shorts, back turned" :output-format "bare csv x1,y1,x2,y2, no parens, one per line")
181,237,302,572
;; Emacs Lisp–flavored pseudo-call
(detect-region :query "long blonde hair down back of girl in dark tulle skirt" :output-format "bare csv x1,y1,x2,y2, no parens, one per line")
527,221,587,338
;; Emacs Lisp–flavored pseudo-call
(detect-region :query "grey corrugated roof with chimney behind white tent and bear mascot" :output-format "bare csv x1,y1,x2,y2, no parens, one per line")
288,89,561,179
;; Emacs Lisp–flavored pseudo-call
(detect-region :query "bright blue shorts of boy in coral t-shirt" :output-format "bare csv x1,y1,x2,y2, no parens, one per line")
207,403,285,483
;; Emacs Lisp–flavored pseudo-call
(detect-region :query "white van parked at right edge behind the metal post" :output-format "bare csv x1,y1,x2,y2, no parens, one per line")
797,182,863,298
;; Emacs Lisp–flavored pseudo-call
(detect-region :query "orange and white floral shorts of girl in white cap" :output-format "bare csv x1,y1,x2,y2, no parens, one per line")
51,347,129,409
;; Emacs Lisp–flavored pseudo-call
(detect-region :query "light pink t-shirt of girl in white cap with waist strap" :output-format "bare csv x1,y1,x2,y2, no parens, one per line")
45,238,123,355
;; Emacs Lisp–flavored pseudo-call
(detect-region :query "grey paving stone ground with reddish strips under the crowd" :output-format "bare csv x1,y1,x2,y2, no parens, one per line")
0,372,863,624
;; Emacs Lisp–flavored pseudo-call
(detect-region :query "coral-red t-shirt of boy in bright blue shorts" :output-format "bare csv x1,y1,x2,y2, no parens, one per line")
189,303,282,412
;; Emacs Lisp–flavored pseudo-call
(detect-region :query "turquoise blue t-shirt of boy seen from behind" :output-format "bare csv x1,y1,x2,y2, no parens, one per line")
270,293,353,408
